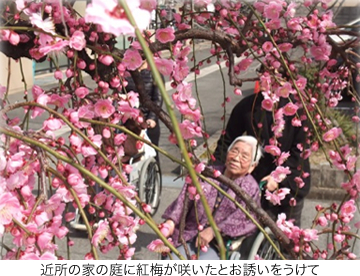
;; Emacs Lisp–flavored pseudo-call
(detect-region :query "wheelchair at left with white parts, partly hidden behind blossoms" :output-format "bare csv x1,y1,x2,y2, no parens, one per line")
70,134,162,231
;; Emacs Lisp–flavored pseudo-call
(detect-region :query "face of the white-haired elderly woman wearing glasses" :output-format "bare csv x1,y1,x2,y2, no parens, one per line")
224,141,255,179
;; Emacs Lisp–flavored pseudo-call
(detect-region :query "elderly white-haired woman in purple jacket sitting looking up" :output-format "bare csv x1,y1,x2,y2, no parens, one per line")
162,136,262,260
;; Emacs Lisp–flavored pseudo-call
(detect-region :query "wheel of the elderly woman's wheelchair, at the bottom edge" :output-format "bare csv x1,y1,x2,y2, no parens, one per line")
248,227,280,260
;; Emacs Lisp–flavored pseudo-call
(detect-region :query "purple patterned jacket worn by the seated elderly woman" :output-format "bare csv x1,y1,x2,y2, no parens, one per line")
162,166,260,247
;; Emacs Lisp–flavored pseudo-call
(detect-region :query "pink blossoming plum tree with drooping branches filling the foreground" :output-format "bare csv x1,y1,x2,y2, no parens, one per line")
0,0,360,259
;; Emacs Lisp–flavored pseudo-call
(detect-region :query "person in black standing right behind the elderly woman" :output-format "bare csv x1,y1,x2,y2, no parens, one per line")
214,90,310,226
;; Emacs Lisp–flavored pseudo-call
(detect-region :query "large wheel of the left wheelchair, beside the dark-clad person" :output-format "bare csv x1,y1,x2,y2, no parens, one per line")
139,157,162,216
